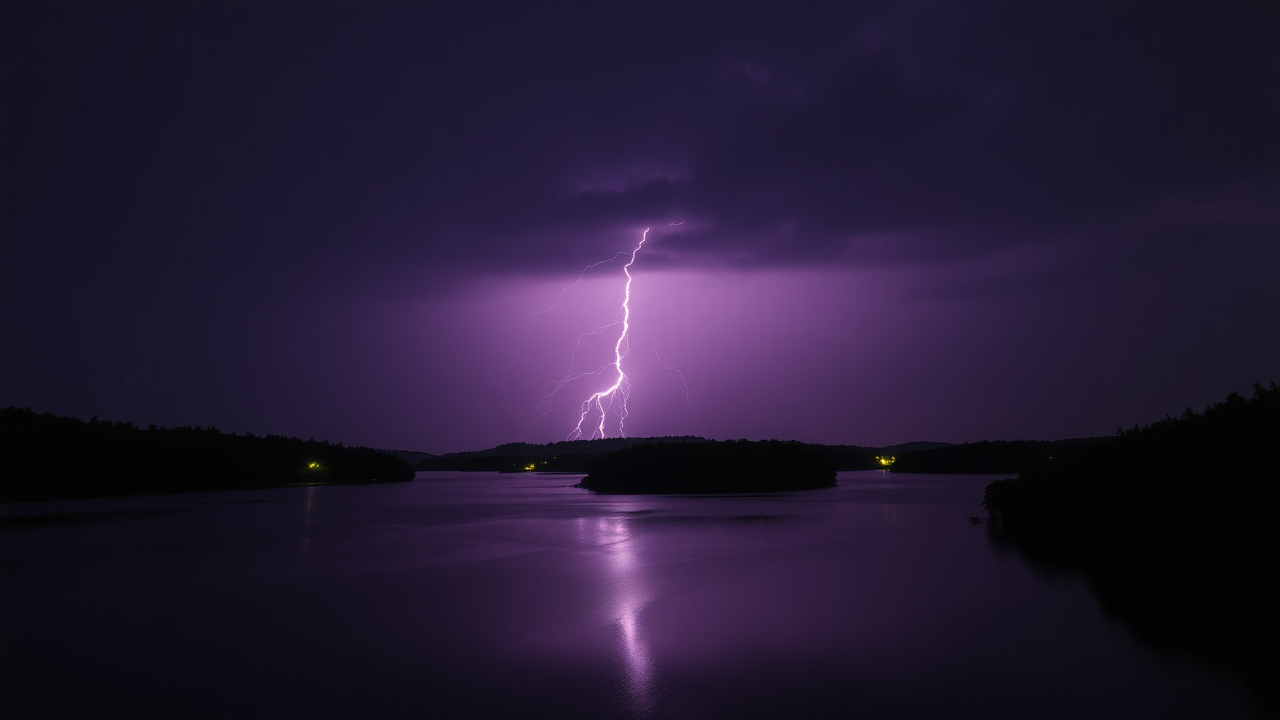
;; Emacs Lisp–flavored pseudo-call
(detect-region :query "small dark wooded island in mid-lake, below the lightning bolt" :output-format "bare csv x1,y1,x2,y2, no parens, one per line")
580,441,836,493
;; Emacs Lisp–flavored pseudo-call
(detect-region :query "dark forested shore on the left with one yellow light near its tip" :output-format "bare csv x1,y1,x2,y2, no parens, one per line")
0,407,413,501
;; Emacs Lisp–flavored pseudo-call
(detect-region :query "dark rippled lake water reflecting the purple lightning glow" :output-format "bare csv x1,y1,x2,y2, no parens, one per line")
0,473,1251,719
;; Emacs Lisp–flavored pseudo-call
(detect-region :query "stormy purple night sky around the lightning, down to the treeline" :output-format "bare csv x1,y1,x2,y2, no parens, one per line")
0,0,1280,452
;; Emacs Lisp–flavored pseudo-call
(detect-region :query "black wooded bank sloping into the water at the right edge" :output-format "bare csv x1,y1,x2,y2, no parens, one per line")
983,383,1280,715
